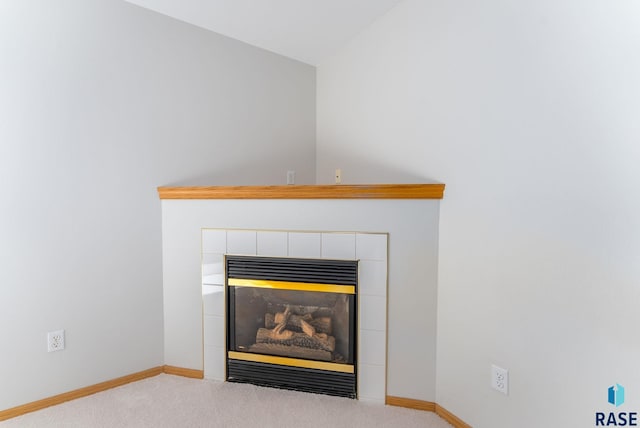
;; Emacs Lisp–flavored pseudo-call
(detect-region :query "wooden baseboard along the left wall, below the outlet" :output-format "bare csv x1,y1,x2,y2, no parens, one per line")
0,366,164,421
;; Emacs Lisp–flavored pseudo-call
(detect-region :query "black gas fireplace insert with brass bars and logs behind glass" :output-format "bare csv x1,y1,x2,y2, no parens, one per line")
225,255,358,398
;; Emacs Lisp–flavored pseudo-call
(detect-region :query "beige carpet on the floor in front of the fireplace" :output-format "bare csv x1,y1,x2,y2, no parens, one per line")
0,374,451,428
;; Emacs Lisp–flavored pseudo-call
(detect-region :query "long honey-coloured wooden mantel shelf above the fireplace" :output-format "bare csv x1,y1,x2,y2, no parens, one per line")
158,184,444,199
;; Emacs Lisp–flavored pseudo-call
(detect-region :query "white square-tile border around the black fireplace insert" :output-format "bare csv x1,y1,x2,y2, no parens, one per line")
202,228,388,403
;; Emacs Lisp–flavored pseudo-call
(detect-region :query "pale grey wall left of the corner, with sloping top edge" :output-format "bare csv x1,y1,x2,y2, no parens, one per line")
0,0,315,410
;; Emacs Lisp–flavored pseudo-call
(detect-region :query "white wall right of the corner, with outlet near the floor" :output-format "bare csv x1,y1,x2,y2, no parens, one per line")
317,0,640,428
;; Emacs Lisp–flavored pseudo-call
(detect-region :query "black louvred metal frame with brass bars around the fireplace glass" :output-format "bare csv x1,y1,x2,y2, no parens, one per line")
225,255,358,398
